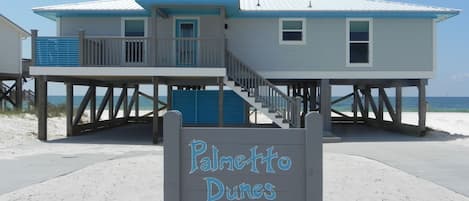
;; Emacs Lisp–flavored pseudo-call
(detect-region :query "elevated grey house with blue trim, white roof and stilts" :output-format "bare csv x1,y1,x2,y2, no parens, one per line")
30,0,459,142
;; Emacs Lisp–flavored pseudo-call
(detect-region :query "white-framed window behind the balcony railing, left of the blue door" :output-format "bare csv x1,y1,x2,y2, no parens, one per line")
122,18,146,64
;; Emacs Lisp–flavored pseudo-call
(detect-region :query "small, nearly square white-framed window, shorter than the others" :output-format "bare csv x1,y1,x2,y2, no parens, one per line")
279,18,306,45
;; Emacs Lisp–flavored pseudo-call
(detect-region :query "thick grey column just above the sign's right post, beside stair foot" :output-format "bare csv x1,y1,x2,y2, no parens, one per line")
320,79,332,131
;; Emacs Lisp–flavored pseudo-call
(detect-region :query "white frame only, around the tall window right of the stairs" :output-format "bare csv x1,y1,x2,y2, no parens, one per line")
345,18,373,67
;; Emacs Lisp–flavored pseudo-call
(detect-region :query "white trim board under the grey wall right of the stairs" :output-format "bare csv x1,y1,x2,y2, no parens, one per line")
258,71,434,79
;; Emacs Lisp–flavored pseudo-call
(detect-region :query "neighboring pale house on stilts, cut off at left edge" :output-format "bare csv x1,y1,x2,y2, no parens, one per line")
0,14,30,109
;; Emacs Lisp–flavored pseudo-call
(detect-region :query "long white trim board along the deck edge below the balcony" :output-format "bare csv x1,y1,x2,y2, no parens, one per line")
29,66,226,77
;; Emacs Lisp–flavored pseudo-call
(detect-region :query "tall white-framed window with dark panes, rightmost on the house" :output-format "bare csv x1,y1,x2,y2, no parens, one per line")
347,19,373,67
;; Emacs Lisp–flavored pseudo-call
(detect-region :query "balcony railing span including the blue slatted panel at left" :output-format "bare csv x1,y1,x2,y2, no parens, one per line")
33,34,225,68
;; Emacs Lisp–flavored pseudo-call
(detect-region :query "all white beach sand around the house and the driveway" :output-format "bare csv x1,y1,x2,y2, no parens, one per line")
0,113,469,201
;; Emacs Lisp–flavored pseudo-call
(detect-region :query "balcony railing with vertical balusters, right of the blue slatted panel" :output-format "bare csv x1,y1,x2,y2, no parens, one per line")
82,37,224,67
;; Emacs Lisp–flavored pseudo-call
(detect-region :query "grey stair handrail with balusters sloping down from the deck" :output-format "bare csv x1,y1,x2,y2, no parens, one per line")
225,50,301,127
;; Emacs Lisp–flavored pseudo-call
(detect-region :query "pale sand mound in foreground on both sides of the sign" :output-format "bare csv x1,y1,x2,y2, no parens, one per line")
0,153,469,201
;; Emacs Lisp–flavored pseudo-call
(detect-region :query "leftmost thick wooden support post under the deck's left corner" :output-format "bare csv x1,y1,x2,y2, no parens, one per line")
36,76,47,141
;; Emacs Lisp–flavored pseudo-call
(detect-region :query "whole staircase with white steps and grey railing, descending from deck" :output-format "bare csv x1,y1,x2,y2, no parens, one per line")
224,50,301,128
